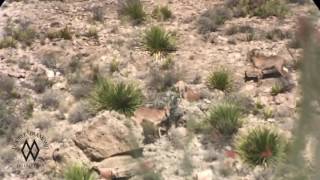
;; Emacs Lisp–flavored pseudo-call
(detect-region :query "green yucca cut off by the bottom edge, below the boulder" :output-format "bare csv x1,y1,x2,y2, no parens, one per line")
64,164,97,180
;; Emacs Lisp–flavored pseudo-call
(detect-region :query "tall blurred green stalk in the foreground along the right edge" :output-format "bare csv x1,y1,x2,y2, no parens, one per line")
285,17,320,180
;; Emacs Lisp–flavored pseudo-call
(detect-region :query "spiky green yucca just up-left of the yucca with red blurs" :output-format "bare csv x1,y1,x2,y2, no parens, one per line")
208,101,242,136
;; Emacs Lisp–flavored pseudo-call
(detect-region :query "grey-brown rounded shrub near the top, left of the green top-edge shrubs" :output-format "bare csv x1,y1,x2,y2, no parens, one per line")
198,7,231,34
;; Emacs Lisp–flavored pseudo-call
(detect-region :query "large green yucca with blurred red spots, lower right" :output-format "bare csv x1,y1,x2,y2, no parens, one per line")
236,127,287,166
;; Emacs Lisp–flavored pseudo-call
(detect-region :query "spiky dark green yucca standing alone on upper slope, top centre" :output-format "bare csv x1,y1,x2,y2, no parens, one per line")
143,26,176,54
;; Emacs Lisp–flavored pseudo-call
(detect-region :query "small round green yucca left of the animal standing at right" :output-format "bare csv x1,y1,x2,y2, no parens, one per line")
207,68,232,91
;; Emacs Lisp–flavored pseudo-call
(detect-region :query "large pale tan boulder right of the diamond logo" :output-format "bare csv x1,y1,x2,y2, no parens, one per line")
74,111,141,161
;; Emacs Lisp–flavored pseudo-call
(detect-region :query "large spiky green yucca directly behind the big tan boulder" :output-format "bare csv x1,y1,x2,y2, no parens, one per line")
92,78,143,116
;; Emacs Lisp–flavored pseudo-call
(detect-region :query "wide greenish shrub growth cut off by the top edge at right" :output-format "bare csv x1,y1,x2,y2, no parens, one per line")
225,0,288,18
